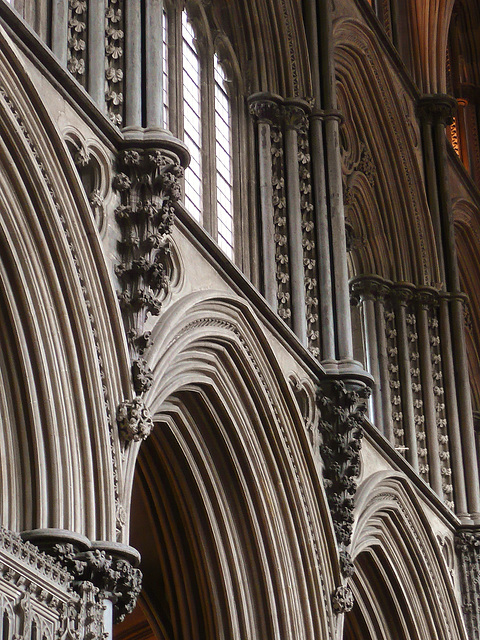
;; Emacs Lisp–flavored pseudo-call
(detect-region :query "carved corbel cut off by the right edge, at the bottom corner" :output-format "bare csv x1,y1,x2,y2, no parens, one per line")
455,529,480,640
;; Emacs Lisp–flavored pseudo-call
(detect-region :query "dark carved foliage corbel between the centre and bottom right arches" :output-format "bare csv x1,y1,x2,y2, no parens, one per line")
317,380,370,576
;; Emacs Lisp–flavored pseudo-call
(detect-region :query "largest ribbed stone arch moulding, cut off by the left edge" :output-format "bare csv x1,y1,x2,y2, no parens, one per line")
0,31,130,541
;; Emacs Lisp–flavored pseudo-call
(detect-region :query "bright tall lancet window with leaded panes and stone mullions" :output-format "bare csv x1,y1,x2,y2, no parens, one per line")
164,6,234,258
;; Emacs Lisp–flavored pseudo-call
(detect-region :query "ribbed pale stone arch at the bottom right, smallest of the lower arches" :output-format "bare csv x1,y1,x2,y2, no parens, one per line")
346,471,466,640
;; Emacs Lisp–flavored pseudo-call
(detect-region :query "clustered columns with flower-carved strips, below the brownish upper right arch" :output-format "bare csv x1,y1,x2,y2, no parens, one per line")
351,276,476,521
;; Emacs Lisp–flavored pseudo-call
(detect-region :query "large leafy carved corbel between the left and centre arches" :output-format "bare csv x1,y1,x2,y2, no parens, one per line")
113,148,183,394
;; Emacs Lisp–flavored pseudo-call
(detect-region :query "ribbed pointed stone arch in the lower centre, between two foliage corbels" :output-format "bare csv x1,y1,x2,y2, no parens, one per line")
125,291,339,639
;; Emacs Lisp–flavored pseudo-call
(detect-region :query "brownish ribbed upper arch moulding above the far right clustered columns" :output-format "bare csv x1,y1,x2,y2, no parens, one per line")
334,19,439,285
